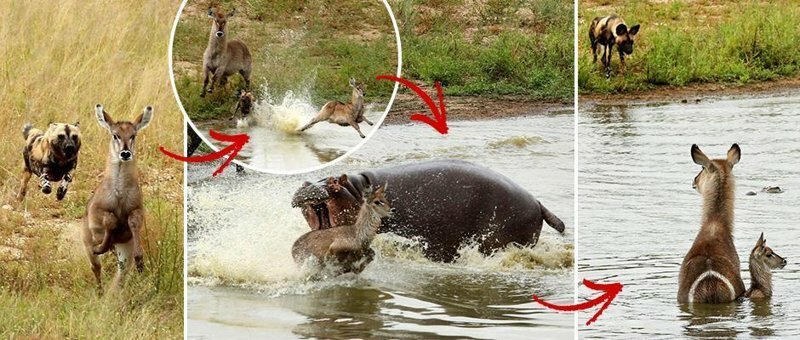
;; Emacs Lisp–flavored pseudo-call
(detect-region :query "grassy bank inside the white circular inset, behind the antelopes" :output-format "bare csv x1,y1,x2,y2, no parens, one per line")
173,0,397,120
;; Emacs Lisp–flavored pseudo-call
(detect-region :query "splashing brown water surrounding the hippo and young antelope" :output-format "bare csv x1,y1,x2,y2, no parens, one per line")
187,112,574,339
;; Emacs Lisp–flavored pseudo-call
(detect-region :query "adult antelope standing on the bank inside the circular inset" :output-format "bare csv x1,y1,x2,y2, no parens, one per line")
200,7,252,97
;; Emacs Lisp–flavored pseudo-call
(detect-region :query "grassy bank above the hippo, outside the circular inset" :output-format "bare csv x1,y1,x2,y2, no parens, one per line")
390,0,573,100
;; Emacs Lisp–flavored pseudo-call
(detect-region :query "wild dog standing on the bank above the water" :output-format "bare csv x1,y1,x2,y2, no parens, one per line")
589,14,639,78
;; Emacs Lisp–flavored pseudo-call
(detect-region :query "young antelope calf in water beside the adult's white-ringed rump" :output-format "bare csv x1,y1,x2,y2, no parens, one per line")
744,233,786,299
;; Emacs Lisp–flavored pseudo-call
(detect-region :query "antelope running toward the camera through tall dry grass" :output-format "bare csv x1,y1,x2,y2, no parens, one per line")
83,104,153,288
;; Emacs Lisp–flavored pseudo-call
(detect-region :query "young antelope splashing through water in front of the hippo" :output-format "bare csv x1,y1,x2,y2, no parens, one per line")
292,186,391,274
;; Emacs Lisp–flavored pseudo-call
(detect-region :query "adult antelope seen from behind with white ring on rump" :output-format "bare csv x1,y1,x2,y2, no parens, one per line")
678,144,745,303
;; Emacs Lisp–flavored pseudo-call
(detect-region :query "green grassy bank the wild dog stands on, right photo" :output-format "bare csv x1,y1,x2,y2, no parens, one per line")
578,0,800,93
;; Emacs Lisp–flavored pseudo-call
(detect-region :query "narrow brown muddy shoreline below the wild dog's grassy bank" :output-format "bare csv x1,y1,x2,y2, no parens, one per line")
578,77,800,111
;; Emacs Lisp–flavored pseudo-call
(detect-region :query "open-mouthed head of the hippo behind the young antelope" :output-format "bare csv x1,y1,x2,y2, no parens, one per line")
292,175,361,230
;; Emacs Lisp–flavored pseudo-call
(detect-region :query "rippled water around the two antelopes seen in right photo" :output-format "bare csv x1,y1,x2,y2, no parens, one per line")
578,97,800,339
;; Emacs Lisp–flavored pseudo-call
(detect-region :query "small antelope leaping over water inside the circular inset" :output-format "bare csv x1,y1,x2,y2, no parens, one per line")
299,78,372,138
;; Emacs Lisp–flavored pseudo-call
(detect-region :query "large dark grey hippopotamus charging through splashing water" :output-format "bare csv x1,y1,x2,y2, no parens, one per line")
292,160,564,262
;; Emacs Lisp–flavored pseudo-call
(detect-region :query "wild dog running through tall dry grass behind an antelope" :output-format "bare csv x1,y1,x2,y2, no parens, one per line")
17,123,81,201
